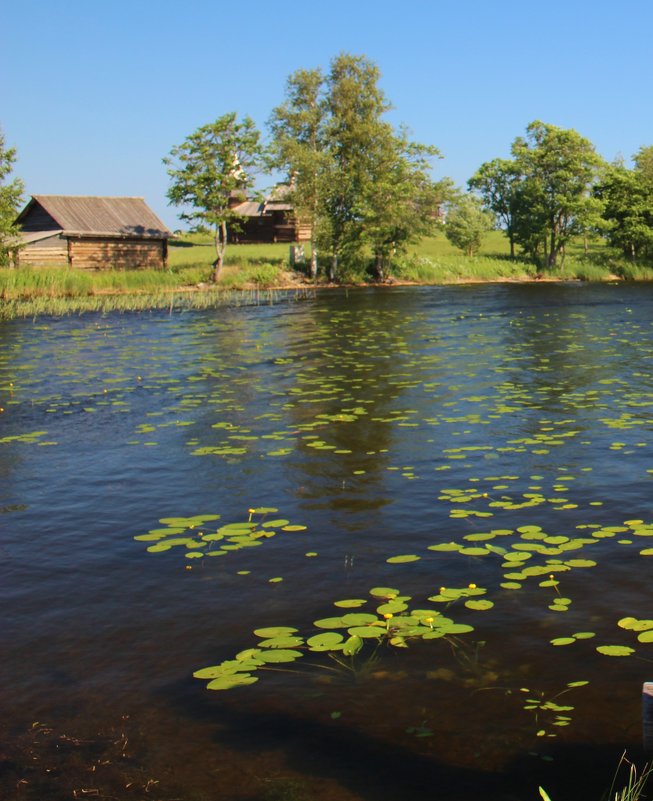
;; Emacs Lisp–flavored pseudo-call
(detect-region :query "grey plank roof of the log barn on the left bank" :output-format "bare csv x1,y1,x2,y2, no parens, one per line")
16,195,171,239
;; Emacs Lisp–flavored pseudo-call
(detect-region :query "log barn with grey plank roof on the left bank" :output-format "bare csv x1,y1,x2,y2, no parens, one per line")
16,195,172,269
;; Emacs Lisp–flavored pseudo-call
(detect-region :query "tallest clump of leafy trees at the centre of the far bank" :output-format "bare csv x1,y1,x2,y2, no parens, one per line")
269,53,444,279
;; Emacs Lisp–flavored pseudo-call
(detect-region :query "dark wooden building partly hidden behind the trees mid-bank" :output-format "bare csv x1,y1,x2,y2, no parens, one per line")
231,184,311,244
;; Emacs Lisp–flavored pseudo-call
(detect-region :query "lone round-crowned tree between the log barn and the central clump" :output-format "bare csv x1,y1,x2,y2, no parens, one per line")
163,112,262,281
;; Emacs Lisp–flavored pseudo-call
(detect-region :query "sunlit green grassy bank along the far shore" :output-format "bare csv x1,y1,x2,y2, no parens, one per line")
0,231,653,319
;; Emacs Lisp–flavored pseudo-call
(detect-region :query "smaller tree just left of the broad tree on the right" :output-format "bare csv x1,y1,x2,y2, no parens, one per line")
467,159,521,258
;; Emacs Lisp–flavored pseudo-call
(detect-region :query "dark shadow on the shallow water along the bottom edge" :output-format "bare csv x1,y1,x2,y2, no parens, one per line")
165,683,646,801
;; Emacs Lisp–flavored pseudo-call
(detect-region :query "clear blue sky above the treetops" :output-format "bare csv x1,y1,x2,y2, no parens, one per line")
0,0,653,228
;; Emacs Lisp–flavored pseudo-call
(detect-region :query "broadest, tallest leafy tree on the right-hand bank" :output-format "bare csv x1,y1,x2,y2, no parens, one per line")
512,120,605,268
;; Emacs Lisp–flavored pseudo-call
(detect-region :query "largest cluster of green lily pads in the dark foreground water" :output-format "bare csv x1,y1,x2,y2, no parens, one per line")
193,586,478,690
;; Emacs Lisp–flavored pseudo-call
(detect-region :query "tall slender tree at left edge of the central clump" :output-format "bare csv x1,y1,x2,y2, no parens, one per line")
268,69,329,278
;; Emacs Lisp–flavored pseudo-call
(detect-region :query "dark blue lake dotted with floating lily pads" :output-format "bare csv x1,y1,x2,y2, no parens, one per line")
0,283,653,801
